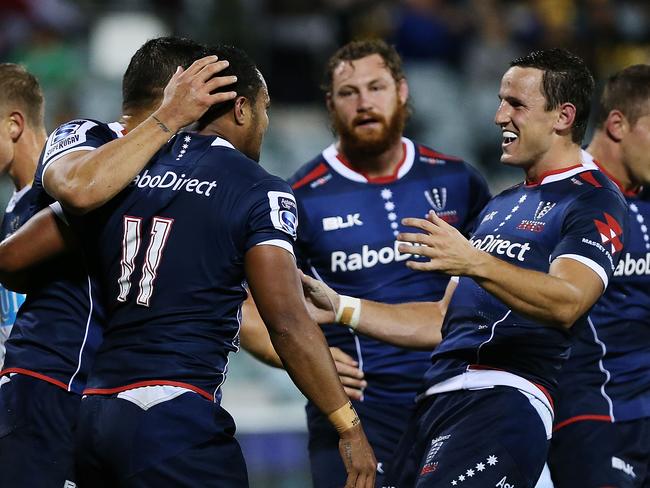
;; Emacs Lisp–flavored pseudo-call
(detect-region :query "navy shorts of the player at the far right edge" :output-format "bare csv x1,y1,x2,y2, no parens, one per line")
548,418,650,488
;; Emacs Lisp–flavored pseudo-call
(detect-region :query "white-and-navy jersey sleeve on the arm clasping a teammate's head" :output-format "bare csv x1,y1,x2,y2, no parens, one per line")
39,119,122,179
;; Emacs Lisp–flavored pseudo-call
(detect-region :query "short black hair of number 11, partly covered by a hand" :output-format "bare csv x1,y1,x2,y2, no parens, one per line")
196,44,264,130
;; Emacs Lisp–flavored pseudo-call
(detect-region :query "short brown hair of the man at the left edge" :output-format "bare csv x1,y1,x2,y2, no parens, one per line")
0,63,44,127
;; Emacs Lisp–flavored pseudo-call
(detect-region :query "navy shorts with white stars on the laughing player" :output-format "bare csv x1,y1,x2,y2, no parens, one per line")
385,386,549,488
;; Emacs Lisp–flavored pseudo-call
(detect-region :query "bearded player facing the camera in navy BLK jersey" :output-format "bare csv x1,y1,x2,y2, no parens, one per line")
282,40,490,487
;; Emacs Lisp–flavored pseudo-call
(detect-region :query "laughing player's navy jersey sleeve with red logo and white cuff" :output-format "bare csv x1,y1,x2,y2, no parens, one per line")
550,189,627,288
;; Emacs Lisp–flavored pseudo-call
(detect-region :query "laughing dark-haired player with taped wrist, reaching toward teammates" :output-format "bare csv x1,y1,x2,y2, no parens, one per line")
303,49,626,487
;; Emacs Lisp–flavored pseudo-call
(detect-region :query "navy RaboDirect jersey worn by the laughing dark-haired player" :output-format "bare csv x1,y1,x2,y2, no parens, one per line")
425,164,627,397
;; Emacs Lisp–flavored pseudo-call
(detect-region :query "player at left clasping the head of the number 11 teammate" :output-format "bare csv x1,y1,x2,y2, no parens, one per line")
0,39,234,487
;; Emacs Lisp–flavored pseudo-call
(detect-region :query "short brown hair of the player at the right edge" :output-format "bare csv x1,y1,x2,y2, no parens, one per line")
596,64,650,127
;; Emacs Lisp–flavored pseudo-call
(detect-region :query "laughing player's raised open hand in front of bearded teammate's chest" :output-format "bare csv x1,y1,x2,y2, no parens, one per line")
397,212,481,276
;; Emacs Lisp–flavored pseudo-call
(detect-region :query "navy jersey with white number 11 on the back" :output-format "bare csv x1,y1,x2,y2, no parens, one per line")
81,133,297,401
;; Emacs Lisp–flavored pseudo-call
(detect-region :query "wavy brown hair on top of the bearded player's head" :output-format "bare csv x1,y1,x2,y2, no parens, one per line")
321,39,404,93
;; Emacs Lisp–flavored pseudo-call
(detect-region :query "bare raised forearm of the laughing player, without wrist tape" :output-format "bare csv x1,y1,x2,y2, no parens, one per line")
467,252,590,328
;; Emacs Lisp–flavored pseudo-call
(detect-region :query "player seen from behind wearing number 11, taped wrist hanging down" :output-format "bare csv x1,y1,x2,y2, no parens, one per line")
42,43,376,487
